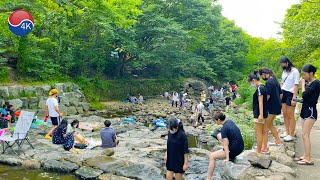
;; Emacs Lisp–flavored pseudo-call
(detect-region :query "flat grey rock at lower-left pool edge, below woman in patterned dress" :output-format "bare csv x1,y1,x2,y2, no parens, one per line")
43,160,79,173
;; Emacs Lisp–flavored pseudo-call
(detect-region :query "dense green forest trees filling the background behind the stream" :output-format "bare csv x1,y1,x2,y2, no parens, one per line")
0,0,320,100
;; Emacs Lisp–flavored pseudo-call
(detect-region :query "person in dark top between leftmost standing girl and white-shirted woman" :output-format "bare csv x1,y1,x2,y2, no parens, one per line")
259,68,282,152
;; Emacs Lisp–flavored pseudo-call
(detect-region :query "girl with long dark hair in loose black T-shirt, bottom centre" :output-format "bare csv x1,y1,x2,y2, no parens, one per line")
164,119,189,180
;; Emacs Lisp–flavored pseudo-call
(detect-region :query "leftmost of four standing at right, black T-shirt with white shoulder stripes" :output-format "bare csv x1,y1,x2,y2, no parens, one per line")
248,71,268,154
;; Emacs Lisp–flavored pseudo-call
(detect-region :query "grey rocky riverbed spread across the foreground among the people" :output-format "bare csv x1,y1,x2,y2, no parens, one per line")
0,99,295,180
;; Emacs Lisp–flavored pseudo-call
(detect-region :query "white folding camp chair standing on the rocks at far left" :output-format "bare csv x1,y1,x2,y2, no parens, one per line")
0,111,35,156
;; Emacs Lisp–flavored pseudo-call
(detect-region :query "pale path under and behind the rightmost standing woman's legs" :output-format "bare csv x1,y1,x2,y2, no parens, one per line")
293,104,320,180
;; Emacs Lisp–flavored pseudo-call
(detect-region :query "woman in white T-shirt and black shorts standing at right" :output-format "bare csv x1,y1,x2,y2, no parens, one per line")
280,56,300,142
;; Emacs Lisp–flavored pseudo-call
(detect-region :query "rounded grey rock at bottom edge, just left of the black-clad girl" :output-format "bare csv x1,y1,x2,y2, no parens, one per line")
115,163,164,180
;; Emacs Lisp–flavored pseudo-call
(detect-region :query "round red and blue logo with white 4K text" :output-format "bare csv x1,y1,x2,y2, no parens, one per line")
8,10,34,36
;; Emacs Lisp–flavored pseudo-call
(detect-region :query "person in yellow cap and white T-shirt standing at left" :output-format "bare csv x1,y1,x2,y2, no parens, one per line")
44,89,62,139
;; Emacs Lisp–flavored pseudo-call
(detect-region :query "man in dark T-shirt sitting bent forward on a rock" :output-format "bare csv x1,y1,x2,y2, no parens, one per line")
207,112,244,180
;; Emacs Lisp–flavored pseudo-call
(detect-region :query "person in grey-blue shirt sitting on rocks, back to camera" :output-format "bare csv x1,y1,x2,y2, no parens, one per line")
100,120,118,148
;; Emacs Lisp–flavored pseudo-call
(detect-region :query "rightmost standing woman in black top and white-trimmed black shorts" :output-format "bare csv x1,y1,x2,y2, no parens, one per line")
295,64,320,165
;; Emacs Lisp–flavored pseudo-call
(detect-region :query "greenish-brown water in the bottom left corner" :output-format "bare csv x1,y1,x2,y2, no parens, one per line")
0,164,76,180
